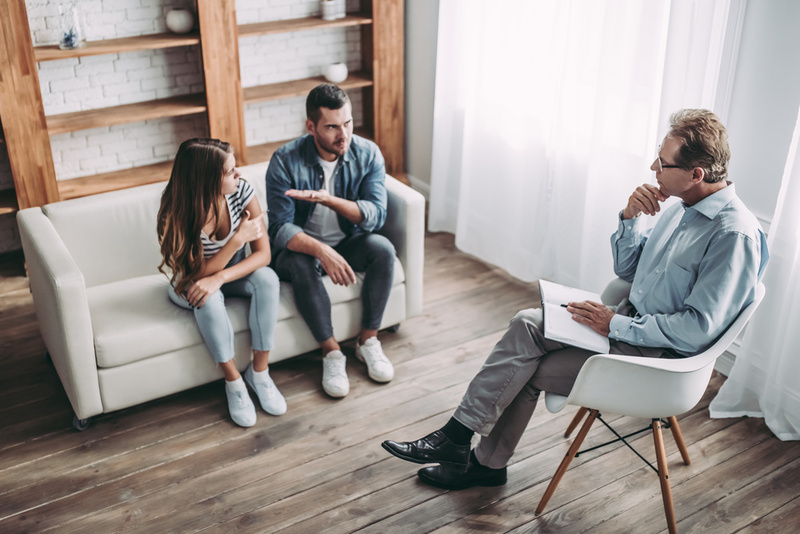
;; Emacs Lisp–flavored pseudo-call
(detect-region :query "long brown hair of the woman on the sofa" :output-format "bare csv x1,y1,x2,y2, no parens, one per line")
157,139,233,295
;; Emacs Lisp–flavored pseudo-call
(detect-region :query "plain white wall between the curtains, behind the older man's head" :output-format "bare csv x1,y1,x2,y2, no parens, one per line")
727,0,800,227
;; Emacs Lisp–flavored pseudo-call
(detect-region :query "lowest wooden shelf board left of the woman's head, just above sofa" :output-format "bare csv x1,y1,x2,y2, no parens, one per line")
58,161,172,200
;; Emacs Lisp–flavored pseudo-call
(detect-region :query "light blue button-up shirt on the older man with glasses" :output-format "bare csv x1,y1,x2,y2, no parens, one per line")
608,182,769,356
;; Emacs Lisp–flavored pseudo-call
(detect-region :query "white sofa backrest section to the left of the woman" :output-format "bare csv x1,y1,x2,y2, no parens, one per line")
42,182,166,287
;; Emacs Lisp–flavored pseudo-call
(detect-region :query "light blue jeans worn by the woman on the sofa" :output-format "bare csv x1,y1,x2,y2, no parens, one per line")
169,254,280,363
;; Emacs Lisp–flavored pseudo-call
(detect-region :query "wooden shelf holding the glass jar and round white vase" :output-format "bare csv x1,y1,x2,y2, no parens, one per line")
33,32,200,61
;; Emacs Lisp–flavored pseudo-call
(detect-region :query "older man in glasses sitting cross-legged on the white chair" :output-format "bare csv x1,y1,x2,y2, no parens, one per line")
383,110,769,489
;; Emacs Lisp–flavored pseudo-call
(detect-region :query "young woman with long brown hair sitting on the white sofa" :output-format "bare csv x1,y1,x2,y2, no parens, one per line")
158,139,286,427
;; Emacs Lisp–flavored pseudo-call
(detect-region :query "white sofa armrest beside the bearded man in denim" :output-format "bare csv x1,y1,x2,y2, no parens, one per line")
378,175,425,317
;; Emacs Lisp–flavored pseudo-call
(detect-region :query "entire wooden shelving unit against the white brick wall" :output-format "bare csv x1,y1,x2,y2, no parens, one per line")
0,0,404,214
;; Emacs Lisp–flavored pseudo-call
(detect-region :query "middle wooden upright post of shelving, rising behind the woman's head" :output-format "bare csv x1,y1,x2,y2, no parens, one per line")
197,0,247,165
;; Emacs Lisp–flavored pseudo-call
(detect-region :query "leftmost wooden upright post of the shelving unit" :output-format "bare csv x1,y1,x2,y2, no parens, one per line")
0,0,59,209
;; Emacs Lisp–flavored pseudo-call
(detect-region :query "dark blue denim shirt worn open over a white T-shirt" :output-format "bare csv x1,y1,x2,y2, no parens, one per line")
266,135,386,253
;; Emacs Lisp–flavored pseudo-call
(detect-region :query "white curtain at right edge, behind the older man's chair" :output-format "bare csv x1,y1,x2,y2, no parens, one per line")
709,102,800,440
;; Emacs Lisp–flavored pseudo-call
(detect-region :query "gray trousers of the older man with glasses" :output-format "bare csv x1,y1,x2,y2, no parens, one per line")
453,308,675,469
